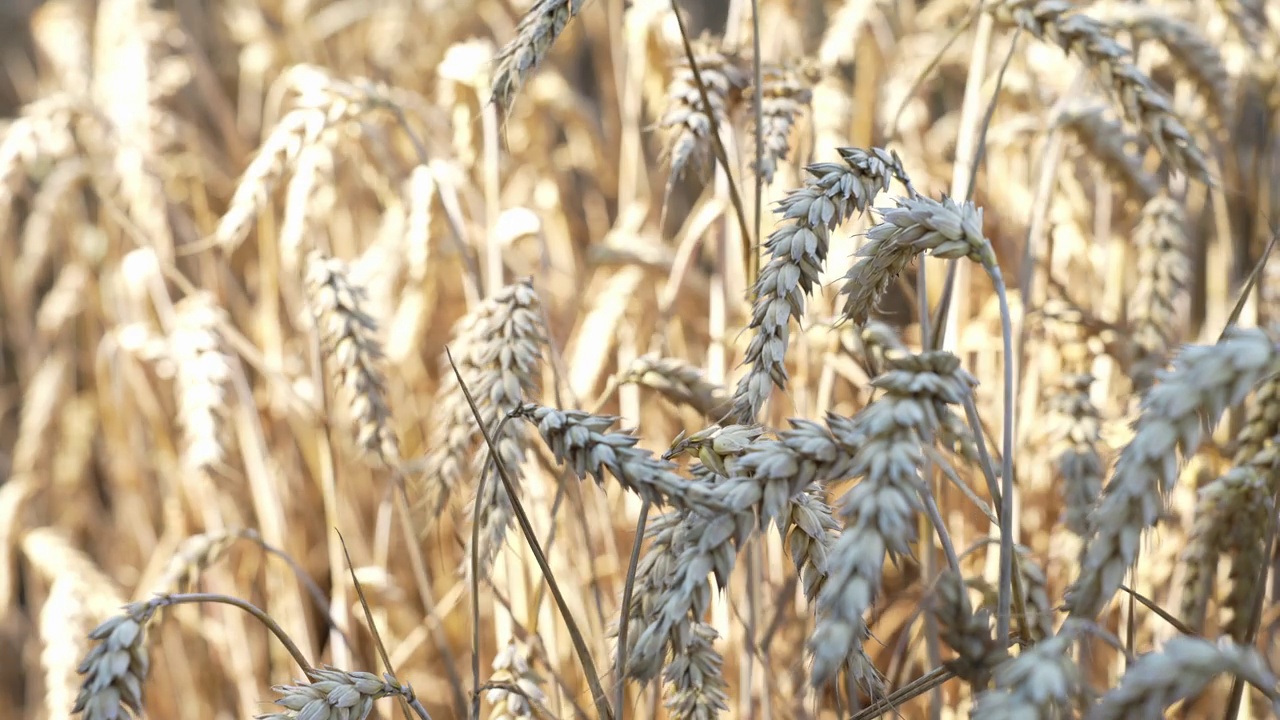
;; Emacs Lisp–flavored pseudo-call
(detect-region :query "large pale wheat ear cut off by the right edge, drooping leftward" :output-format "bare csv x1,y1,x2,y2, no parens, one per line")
1066,328,1276,618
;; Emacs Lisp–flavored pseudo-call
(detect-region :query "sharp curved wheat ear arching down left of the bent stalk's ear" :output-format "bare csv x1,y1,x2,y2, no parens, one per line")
733,147,909,423
